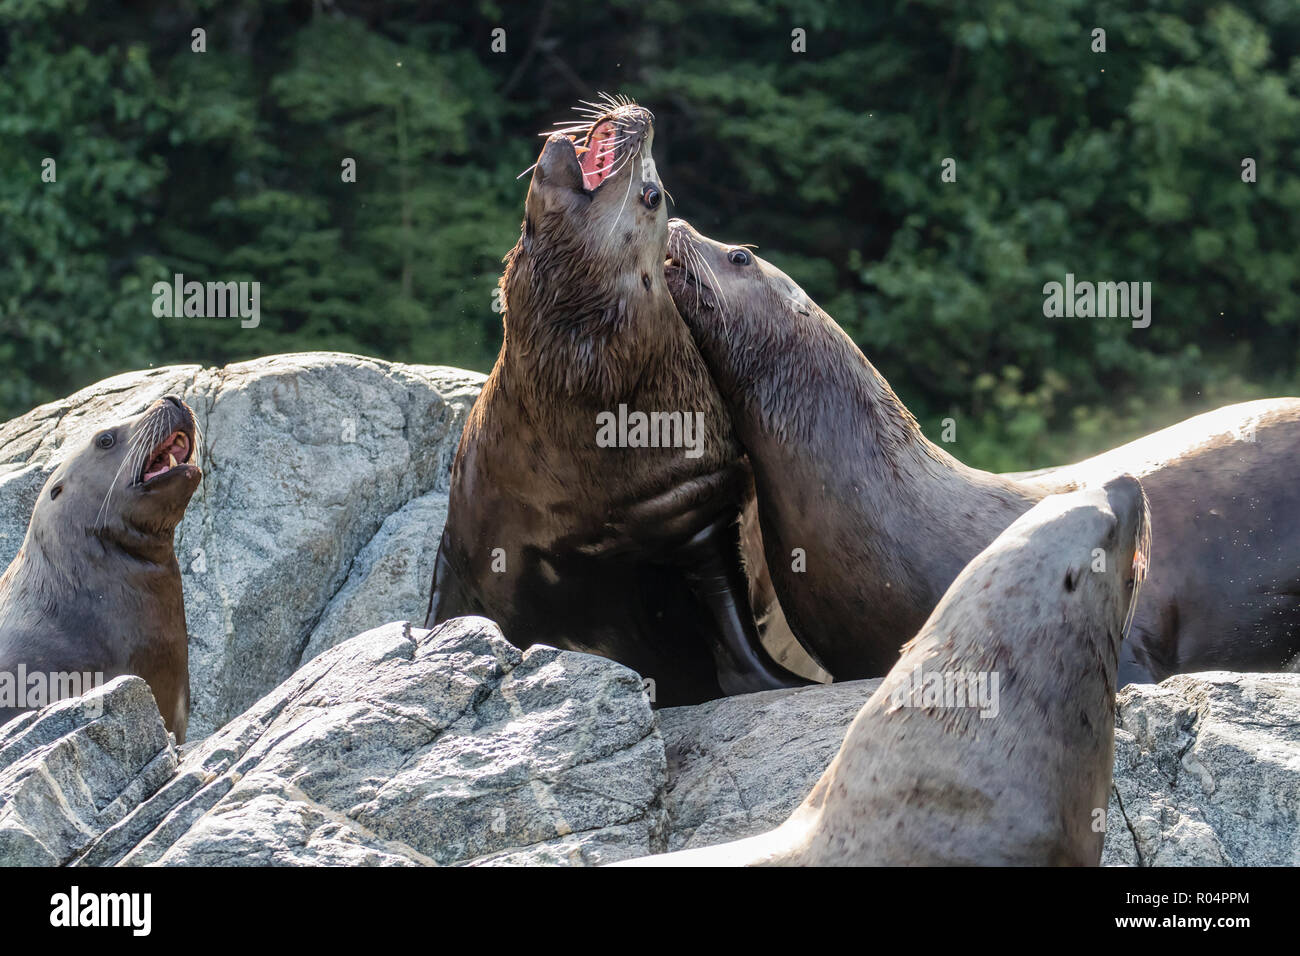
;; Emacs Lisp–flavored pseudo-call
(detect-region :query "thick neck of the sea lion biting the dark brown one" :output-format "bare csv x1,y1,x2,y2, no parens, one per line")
670,260,1045,679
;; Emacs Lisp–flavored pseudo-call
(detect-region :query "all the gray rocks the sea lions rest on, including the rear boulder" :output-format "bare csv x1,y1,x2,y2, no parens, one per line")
0,354,1300,865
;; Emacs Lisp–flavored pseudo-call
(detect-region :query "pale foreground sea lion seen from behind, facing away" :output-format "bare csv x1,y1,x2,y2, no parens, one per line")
618,475,1149,866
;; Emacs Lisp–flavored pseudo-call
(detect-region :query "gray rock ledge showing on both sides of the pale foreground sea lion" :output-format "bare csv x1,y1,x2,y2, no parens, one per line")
659,672,1300,866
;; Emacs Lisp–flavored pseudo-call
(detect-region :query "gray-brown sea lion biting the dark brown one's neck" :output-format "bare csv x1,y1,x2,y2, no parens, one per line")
664,220,1300,684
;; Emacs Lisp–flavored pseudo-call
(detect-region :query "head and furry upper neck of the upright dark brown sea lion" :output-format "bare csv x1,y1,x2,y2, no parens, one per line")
498,96,681,398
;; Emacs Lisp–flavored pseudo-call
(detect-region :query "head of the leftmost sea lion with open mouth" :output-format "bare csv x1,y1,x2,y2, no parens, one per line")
31,395,203,561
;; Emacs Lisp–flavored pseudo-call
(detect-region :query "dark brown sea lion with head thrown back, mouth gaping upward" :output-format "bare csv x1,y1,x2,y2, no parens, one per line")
426,98,806,704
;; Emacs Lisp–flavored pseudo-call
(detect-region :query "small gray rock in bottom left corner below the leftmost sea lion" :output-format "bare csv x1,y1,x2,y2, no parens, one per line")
0,676,177,866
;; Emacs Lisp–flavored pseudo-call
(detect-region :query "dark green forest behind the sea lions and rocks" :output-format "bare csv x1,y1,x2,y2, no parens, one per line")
0,0,1300,470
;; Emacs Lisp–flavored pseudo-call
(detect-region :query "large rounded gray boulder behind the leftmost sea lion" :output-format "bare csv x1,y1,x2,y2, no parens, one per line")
0,352,482,740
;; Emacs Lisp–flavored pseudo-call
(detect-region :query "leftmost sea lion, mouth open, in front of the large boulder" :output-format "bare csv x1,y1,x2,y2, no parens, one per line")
0,395,203,743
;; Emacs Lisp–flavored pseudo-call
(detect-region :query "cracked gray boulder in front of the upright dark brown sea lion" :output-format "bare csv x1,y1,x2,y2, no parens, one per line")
78,618,666,866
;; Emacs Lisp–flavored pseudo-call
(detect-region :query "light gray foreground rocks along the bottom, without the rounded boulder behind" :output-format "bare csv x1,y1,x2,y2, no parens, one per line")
0,618,1300,865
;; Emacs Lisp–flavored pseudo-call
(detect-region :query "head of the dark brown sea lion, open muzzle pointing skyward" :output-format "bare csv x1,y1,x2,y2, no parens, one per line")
507,96,668,291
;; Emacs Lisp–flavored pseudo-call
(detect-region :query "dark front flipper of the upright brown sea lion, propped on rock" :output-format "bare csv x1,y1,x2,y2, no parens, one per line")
676,519,813,695
